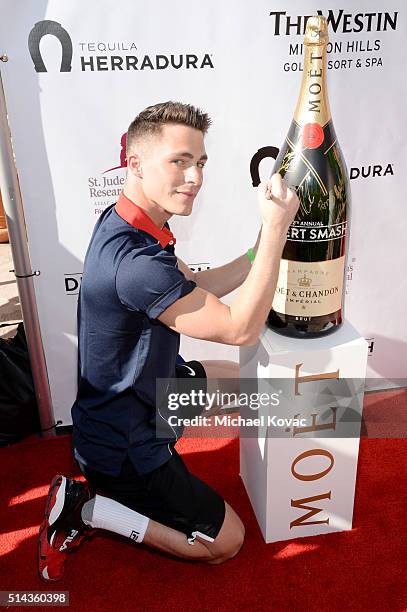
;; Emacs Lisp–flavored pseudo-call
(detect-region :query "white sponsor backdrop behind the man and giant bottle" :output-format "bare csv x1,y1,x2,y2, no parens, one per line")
0,0,407,424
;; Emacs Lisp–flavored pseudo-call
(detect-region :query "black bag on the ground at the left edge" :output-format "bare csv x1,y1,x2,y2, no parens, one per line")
0,323,40,447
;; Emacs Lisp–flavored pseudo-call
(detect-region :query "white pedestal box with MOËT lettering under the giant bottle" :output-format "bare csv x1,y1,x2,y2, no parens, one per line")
240,322,368,542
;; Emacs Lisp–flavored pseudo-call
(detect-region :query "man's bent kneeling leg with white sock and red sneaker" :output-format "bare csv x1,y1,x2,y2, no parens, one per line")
38,456,244,582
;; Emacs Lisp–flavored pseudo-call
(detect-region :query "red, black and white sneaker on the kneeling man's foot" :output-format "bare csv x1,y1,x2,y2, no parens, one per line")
38,475,94,582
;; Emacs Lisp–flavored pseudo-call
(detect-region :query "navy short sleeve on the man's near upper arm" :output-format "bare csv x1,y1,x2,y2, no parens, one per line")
116,249,196,319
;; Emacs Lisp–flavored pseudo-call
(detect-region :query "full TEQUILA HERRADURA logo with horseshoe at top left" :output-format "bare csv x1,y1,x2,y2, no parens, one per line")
28,19,214,73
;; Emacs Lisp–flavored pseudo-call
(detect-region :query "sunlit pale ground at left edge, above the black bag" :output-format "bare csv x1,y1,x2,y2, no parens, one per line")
0,243,22,338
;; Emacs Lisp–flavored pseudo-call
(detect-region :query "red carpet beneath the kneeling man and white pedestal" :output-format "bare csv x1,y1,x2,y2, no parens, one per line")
0,392,407,612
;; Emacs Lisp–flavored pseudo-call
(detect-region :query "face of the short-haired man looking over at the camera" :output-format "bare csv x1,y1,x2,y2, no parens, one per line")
131,124,207,215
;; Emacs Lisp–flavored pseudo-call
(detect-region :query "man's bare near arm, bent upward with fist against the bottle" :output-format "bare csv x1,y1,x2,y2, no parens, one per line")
158,174,299,345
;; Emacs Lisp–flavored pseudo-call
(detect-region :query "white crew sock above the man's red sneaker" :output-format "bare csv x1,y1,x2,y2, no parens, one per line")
82,495,150,542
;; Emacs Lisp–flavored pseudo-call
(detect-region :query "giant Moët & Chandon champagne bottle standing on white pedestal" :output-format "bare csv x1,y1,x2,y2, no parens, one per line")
267,17,349,338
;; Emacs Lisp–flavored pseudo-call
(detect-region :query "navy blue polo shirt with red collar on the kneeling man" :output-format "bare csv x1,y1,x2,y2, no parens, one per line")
72,193,196,476
